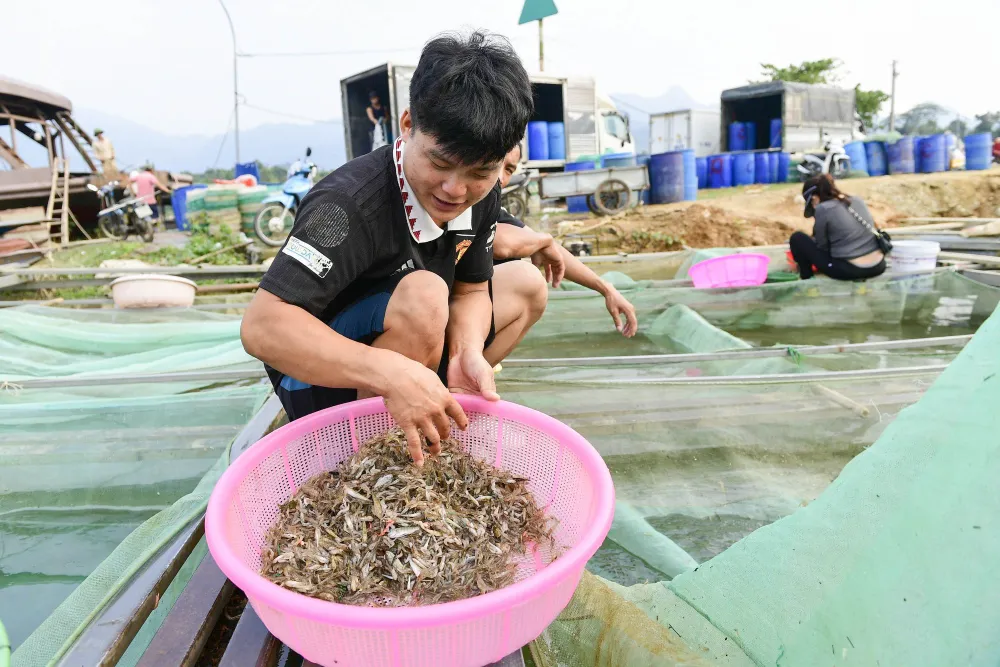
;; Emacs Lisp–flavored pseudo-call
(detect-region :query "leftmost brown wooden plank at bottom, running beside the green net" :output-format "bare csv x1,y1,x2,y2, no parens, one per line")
58,517,205,667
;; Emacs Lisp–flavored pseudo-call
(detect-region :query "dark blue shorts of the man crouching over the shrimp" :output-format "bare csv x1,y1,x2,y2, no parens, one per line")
274,273,496,421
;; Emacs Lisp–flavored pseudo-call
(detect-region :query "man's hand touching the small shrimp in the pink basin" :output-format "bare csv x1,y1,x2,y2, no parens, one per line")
383,355,468,466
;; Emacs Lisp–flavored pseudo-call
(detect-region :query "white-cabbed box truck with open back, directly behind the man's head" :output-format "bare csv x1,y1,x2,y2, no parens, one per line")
340,63,635,171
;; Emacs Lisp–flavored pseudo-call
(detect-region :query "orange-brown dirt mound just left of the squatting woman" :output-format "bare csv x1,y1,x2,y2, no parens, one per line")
601,204,794,252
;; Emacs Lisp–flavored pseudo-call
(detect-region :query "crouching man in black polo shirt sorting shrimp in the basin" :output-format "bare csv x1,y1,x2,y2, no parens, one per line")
240,32,537,464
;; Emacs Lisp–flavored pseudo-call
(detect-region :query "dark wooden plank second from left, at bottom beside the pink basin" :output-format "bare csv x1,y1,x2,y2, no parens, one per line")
137,554,233,667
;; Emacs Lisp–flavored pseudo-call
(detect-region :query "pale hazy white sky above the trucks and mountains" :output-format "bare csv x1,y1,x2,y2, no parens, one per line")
7,0,1000,134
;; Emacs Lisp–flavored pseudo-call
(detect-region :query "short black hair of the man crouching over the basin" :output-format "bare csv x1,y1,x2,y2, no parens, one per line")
410,31,535,165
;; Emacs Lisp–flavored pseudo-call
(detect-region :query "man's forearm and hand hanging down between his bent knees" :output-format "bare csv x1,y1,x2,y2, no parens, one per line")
445,281,500,401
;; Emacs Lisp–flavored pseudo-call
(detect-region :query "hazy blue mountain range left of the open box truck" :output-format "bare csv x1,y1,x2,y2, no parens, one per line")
73,109,346,172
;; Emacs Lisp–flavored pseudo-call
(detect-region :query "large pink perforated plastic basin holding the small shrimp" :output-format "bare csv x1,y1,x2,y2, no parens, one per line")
205,396,615,667
